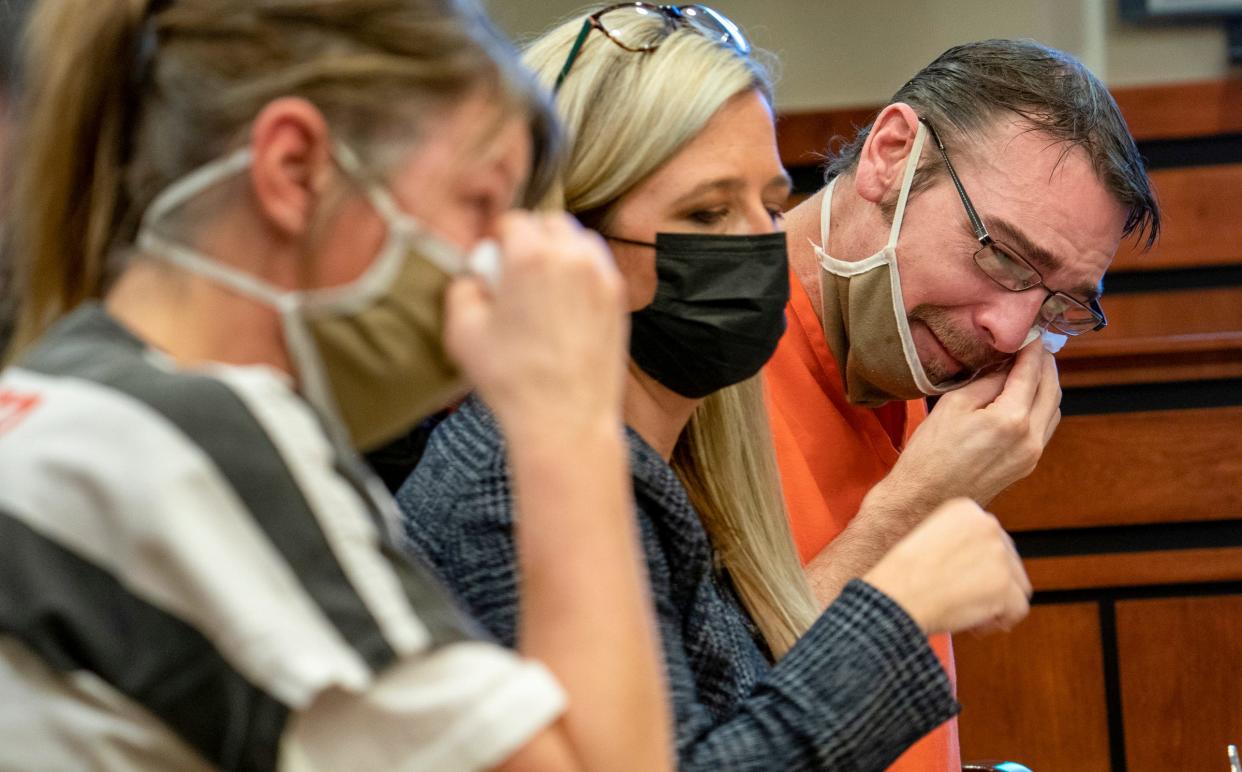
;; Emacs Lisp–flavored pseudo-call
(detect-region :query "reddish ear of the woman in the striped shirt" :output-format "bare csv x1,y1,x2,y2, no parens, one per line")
250,97,334,238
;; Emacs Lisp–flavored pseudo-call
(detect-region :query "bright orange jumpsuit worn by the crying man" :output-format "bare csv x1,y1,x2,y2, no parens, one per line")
764,274,961,772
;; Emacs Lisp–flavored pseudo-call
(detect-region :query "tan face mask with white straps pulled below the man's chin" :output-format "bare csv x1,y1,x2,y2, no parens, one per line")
811,123,1040,407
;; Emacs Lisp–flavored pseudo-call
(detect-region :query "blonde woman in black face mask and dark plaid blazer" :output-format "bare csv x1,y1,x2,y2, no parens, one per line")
399,2,1028,771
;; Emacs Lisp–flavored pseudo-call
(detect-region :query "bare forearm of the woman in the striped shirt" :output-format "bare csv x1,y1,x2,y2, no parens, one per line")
507,417,672,770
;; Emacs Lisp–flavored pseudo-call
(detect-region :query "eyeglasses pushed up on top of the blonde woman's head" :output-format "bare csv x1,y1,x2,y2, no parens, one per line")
553,2,750,91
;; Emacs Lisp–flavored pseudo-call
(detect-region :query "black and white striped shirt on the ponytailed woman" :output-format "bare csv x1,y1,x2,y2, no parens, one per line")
0,305,564,770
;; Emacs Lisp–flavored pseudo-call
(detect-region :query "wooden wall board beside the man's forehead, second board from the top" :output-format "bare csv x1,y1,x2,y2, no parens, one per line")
1105,164,1242,271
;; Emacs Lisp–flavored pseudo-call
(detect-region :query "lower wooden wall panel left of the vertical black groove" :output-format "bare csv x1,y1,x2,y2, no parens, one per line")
954,603,1109,772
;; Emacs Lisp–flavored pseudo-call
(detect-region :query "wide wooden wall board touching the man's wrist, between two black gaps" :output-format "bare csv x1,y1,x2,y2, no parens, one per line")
991,406,1242,531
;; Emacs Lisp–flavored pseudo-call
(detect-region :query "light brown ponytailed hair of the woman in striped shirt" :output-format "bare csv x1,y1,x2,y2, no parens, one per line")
11,0,555,359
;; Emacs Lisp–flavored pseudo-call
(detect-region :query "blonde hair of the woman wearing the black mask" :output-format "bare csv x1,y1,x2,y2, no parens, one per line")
523,7,818,657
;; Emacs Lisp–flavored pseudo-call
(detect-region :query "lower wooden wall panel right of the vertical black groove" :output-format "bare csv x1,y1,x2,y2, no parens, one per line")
1117,596,1242,772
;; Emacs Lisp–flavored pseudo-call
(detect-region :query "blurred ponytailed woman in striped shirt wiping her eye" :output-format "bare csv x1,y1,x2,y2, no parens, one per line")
0,0,672,771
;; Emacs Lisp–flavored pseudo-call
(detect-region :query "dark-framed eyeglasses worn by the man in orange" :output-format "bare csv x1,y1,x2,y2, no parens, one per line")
920,119,1108,335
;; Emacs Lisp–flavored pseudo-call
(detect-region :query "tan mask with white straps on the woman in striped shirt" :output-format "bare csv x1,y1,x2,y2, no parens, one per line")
138,146,498,451
